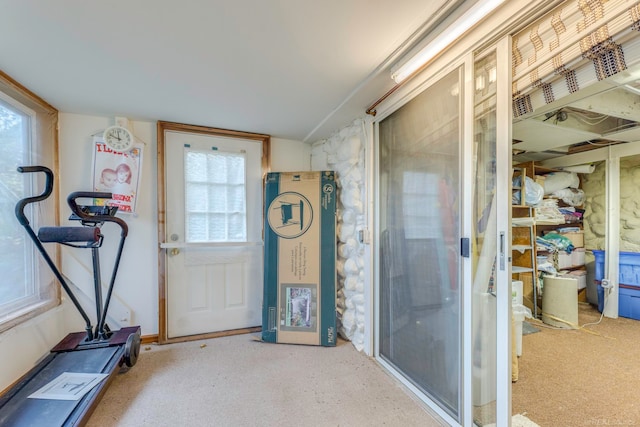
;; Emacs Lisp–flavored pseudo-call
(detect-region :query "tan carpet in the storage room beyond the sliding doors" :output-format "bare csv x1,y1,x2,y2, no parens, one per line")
512,303,640,427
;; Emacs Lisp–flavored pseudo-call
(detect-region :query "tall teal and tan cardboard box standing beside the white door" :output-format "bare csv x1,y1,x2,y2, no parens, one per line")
262,171,337,346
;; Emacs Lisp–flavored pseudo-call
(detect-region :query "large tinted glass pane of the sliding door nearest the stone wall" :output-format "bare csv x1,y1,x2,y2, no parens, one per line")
379,66,463,419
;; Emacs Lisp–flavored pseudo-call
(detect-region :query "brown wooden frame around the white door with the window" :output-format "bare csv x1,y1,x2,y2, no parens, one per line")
156,121,271,344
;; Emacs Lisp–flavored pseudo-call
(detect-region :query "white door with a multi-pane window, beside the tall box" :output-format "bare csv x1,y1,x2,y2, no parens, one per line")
162,131,263,339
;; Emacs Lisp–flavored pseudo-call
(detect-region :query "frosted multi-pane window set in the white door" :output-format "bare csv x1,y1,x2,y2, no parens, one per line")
184,148,247,242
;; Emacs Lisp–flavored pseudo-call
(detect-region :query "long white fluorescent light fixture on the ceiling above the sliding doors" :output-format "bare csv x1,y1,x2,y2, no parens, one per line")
391,0,504,83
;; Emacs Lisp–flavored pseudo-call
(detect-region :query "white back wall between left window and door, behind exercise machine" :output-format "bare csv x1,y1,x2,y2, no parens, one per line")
58,113,158,335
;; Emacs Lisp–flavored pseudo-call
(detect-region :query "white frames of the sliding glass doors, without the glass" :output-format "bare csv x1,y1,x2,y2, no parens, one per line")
371,36,511,426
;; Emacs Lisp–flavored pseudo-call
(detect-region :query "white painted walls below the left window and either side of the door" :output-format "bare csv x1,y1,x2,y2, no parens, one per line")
0,113,311,391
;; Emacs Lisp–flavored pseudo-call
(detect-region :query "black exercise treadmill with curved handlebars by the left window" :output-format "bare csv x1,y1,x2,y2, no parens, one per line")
0,166,140,426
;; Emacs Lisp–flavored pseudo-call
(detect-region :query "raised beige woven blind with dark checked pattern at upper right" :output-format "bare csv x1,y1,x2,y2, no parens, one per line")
512,0,640,117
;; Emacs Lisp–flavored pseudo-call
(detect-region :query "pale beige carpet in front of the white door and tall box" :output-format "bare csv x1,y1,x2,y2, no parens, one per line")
87,335,443,427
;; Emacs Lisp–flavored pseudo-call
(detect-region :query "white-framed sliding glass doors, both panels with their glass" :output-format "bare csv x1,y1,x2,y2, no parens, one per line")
376,39,511,426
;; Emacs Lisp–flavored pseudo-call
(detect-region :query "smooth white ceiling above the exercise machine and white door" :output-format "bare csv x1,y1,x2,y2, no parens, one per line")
0,0,456,143
